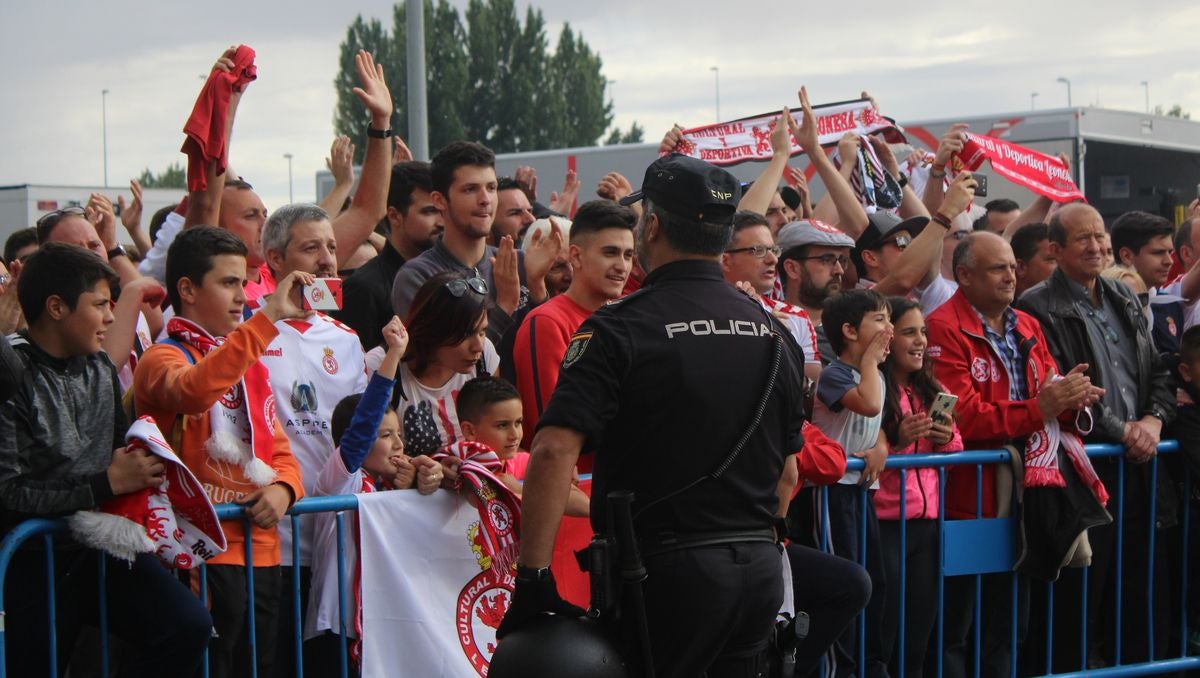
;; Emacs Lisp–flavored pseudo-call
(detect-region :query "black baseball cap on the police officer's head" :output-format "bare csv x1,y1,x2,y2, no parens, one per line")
620,154,742,223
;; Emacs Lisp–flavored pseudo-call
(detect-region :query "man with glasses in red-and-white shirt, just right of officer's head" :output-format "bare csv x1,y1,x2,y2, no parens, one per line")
721,211,821,382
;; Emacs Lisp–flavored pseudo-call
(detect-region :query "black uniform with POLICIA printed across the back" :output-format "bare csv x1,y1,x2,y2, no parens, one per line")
539,260,804,678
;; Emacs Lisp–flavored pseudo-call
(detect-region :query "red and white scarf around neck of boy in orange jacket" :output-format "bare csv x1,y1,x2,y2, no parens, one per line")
167,316,277,487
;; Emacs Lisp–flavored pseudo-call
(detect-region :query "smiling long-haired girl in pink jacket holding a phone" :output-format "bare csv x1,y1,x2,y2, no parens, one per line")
875,296,962,677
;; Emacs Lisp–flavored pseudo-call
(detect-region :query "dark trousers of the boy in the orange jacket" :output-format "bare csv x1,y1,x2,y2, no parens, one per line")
208,565,281,678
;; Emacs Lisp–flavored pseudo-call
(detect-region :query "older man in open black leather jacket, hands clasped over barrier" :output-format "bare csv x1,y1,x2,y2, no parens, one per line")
1018,203,1175,668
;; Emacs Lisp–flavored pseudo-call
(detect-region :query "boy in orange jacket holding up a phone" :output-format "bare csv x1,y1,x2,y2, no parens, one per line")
133,226,312,676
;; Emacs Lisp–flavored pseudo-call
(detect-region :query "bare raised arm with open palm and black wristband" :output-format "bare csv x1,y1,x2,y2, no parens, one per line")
334,50,392,266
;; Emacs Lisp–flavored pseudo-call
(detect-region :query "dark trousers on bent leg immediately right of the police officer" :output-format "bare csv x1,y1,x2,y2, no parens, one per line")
787,544,871,676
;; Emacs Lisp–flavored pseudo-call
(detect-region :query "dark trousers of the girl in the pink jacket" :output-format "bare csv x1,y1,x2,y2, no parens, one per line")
880,520,941,678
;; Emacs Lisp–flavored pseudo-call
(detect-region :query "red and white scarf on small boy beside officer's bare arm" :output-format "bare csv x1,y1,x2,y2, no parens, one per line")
433,440,521,575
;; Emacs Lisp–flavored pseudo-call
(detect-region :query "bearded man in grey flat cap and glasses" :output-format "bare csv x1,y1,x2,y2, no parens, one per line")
776,220,854,364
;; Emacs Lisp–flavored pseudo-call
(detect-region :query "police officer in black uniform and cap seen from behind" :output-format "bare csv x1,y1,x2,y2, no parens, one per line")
500,154,804,678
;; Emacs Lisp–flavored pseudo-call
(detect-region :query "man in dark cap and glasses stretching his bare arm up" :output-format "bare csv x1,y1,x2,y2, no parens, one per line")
852,172,976,314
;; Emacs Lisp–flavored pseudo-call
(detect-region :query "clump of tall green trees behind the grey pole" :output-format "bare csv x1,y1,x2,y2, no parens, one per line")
334,0,612,154
